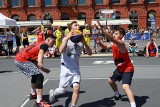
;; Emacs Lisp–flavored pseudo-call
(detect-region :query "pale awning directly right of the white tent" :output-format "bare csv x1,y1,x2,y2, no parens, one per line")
17,20,51,26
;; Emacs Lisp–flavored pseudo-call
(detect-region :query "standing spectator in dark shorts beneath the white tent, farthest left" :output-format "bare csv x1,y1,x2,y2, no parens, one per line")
6,28,14,55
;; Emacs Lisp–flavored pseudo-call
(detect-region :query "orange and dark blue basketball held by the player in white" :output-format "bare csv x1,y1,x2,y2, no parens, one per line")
70,30,83,43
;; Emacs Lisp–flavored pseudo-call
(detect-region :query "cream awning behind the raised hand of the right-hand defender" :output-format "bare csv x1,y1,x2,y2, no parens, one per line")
92,19,132,25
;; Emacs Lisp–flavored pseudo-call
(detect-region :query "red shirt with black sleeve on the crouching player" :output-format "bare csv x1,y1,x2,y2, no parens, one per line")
15,42,48,62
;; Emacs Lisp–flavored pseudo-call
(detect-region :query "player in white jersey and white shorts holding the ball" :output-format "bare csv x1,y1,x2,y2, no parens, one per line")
49,21,92,107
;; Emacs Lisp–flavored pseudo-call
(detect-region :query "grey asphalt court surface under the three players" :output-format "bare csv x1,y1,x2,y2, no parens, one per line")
0,56,160,107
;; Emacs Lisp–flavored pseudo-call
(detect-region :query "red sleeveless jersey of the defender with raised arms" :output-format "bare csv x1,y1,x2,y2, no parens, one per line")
112,44,134,73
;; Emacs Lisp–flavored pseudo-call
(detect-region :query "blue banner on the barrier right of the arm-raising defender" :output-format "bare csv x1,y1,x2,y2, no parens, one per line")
125,33,150,40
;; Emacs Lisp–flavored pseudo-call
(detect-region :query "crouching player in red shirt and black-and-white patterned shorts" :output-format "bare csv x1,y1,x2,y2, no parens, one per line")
15,35,56,107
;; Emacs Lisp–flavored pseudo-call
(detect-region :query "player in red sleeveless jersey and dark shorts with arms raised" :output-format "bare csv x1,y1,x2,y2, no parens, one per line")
97,21,136,107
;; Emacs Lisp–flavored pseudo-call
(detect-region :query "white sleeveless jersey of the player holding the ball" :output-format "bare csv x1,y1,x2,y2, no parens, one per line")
61,39,83,70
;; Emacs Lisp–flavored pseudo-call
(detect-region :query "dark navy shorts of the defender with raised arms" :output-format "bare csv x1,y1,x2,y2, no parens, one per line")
110,69,134,85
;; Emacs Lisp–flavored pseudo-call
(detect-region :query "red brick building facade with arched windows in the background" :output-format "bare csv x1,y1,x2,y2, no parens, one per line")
0,0,160,28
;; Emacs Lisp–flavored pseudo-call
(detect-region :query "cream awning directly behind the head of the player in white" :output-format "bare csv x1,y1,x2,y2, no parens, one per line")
52,20,85,26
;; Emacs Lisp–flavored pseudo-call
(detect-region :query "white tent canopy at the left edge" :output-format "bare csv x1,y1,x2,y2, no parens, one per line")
0,13,16,28
